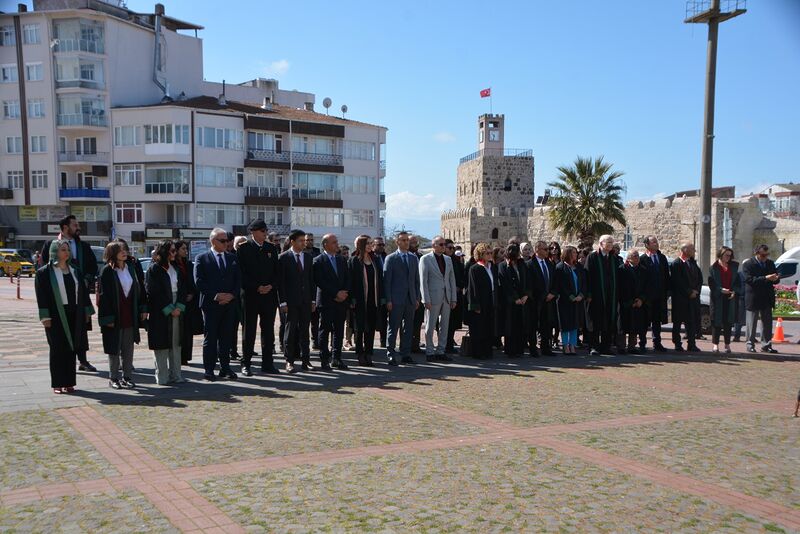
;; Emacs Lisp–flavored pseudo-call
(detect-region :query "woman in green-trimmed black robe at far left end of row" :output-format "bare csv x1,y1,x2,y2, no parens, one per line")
36,239,94,393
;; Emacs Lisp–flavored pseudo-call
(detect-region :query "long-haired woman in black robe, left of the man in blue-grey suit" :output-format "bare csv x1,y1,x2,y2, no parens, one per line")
348,235,386,367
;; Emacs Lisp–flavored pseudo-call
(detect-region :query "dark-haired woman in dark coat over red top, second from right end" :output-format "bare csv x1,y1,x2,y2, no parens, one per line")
708,246,742,354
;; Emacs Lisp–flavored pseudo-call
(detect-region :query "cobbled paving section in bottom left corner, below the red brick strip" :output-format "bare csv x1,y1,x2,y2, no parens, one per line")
0,491,180,534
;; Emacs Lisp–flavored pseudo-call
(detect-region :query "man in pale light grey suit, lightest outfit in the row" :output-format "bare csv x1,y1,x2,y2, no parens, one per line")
419,236,458,362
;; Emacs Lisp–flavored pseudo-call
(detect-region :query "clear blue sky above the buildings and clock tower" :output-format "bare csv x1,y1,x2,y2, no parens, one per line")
7,0,800,236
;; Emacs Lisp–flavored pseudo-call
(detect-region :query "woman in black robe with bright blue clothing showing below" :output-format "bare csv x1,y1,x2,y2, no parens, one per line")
553,246,584,354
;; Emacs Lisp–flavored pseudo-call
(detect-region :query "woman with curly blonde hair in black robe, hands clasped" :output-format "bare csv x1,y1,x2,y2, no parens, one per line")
467,243,499,359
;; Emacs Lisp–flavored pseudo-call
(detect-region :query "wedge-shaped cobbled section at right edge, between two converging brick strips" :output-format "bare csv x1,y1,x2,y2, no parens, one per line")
561,413,800,511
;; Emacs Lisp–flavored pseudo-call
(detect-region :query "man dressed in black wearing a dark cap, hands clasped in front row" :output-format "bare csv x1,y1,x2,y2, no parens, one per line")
237,219,280,376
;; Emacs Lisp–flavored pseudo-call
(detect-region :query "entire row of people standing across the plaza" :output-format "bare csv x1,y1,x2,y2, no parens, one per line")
36,215,778,393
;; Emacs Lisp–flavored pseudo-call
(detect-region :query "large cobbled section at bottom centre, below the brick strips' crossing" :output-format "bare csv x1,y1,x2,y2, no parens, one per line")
194,442,780,533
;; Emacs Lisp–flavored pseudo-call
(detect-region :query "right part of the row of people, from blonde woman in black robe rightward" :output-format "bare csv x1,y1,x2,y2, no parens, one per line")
466,235,780,358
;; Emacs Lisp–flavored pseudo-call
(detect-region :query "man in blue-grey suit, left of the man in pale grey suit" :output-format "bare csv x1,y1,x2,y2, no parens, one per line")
383,232,420,365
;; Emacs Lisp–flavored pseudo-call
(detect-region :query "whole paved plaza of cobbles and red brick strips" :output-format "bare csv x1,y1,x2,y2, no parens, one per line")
0,279,800,533
